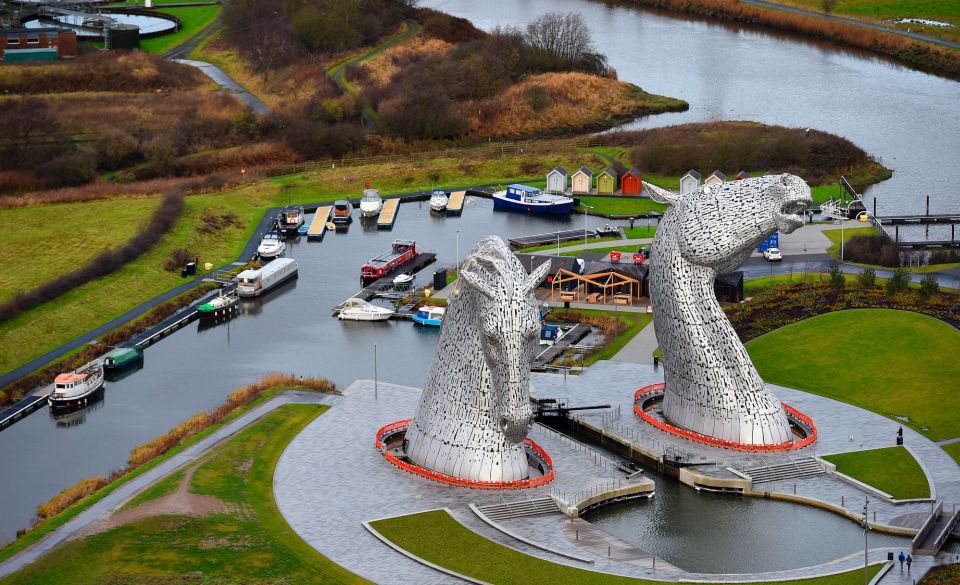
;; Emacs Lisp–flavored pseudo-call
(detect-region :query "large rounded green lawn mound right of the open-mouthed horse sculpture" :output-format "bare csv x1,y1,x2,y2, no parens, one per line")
747,309,960,440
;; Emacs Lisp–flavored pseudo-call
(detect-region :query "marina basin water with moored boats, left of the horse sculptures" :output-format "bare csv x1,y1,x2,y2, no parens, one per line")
0,197,602,540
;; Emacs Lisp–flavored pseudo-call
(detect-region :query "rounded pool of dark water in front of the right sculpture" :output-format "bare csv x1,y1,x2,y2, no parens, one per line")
584,472,910,573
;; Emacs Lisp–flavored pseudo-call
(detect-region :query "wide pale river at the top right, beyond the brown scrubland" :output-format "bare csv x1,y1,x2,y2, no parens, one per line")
422,0,960,239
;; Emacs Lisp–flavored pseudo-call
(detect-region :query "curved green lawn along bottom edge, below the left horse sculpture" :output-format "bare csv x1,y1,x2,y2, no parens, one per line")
370,510,882,585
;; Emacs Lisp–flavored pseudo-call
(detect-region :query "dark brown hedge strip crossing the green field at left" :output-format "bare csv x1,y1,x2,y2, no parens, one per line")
0,189,183,321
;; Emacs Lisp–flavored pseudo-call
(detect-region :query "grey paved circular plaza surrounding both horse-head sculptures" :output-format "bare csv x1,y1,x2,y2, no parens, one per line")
274,361,960,583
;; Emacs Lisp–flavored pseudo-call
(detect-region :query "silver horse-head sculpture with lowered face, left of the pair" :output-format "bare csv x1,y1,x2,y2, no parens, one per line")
404,236,549,482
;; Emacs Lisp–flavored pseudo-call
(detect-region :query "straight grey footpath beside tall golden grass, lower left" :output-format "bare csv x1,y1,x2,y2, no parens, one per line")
0,390,340,579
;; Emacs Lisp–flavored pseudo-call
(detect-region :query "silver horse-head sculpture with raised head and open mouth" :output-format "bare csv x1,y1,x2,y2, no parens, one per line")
646,175,811,445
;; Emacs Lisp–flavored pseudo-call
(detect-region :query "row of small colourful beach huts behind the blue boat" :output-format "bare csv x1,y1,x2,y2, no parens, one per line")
546,166,750,196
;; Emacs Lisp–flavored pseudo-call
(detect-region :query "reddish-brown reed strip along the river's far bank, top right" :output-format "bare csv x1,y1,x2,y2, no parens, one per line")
630,0,960,77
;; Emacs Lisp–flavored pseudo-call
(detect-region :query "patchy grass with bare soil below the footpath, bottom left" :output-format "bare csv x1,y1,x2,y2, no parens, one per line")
2,404,365,584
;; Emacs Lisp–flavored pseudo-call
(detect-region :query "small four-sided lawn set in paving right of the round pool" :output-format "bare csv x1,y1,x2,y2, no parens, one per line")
823,447,930,500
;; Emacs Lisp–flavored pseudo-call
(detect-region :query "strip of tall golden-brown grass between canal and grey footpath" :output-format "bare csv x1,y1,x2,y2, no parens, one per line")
29,372,337,524
